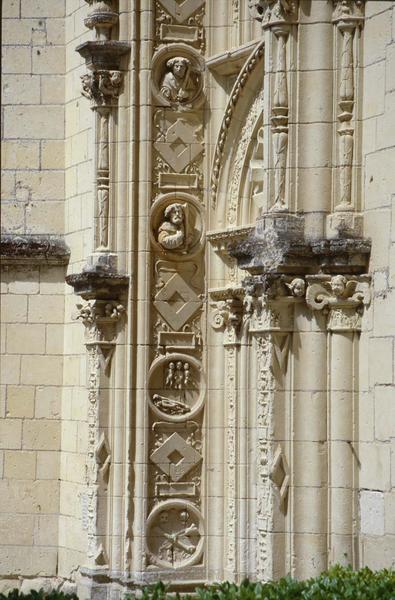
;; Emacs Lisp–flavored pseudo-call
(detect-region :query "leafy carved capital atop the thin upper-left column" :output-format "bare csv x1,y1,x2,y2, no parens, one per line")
81,70,123,107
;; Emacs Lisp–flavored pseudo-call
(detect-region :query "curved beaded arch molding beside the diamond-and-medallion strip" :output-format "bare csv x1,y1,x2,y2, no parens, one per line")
211,40,264,216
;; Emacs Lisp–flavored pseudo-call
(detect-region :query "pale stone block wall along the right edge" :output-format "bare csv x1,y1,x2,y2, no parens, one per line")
359,1,395,568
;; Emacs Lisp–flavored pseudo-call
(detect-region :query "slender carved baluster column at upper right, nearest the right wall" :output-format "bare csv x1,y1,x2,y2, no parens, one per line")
328,0,364,235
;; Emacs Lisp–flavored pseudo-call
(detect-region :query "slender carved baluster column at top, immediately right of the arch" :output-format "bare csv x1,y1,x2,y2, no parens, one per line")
249,0,298,212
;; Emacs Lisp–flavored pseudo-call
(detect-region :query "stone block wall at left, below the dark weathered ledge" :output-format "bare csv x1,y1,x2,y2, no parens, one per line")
0,265,65,585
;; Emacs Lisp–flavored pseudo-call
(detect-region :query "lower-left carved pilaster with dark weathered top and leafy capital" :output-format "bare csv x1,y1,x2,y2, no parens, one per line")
66,272,128,574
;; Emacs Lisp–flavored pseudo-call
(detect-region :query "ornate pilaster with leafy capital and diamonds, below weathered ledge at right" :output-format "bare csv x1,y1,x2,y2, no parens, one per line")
244,275,296,580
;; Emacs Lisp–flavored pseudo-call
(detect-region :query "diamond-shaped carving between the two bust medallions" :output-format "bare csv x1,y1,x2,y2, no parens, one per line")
154,119,203,173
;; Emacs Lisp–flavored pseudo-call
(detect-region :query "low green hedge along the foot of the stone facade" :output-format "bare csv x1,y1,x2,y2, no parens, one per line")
0,565,395,600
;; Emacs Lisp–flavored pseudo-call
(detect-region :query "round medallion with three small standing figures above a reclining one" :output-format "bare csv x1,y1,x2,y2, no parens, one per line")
148,354,205,421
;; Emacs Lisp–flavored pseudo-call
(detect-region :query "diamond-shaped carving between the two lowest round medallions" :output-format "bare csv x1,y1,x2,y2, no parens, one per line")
150,433,202,481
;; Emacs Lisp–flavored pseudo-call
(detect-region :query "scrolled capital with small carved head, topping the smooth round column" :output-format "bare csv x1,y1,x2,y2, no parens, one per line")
306,275,370,331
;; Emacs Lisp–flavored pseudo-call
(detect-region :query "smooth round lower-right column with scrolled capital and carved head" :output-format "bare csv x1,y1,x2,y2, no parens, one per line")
306,275,369,566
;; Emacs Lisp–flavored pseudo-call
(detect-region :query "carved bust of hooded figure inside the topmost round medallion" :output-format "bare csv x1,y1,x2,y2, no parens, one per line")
160,56,199,104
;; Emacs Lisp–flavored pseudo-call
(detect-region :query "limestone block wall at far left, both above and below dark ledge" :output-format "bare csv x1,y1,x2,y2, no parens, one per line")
0,0,65,587
